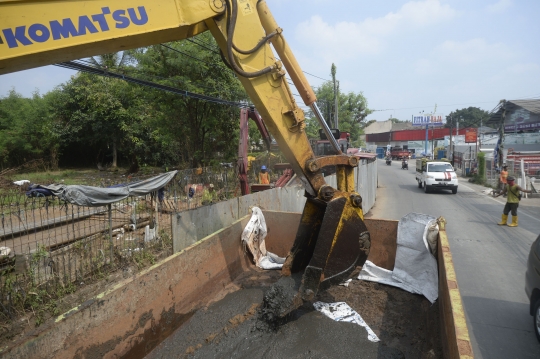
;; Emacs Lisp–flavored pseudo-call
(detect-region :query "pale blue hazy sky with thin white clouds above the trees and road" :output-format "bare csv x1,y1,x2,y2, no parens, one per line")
0,0,540,121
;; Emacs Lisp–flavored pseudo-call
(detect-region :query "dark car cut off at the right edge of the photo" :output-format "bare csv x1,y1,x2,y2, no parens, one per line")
525,235,540,342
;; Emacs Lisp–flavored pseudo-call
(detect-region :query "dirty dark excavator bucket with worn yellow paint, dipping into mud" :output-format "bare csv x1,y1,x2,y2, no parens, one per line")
278,193,371,317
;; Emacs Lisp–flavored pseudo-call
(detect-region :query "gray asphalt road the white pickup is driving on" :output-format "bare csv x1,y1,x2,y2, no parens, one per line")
368,160,540,359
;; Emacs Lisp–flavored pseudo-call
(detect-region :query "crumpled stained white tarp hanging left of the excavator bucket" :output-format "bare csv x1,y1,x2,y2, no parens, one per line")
241,207,285,269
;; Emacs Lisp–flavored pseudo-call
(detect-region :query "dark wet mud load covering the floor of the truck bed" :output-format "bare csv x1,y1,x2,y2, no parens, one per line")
146,272,442,359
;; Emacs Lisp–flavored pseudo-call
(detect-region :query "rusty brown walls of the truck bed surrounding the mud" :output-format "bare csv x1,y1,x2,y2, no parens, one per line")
0,211,472,359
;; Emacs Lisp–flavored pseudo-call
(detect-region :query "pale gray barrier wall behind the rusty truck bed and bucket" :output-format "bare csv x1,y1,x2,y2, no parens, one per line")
172,159,377,253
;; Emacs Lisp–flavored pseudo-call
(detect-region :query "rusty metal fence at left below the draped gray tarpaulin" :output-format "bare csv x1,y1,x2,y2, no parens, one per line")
0,165,246,321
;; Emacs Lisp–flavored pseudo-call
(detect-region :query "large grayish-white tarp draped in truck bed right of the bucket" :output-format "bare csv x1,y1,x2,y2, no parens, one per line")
358,213,439,303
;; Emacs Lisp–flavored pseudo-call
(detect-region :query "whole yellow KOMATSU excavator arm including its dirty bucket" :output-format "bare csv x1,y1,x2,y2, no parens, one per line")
0,0,370,316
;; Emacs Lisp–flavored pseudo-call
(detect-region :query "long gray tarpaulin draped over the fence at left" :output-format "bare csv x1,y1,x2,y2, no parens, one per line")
39,171,178,207
